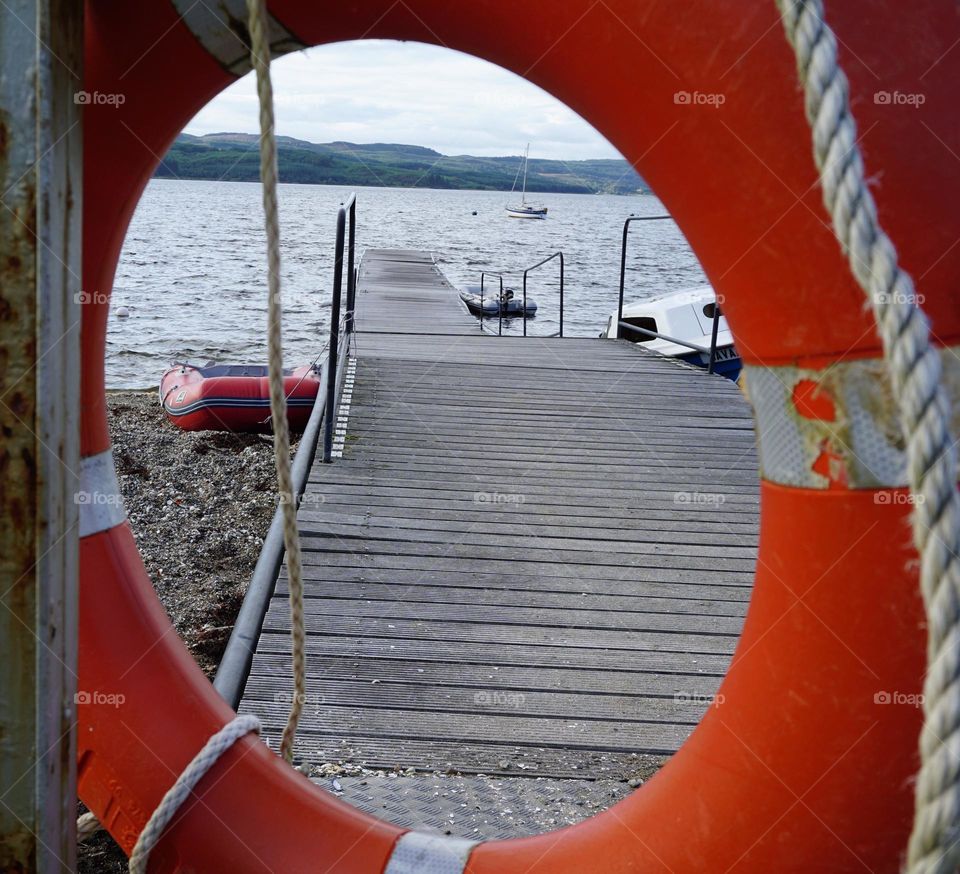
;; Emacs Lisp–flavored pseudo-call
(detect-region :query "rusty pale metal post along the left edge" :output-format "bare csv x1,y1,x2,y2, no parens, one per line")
0,0,83,872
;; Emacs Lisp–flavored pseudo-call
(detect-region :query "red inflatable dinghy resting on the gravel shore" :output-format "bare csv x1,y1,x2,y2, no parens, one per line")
160,364,320,431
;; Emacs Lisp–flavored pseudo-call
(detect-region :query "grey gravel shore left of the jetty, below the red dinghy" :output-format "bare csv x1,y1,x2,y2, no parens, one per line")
108,391,288,676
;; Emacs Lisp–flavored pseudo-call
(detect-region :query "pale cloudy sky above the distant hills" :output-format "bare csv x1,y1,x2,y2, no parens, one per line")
185,40,620,160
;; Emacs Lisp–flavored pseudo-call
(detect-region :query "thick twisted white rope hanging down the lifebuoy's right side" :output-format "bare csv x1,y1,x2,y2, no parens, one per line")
777,0,960,874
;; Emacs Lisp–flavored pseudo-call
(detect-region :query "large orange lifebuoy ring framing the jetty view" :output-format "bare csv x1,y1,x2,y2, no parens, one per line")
78,0,960,874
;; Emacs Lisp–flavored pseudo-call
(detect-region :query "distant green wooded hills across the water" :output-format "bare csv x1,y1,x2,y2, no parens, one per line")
155,133,649,194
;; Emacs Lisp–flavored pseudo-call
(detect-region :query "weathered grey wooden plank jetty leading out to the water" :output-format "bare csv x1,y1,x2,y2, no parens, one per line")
241,250,758,836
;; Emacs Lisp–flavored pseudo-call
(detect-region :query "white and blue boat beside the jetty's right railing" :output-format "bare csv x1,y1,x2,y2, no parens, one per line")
600,285,742,380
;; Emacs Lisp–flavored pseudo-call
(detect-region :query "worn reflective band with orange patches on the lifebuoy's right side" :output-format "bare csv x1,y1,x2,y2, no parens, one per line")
744,348,960,489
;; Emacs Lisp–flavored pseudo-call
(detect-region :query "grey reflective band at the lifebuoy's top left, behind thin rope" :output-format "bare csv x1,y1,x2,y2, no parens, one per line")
172,0,306,76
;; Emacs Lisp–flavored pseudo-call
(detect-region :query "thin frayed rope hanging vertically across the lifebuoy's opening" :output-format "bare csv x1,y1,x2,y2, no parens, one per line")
247,0,306,762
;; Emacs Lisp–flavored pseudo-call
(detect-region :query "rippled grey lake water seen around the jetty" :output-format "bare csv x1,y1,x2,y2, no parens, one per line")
107,179,705,388
